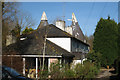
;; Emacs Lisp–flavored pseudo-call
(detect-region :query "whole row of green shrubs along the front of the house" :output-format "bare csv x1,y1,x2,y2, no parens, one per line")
40,61,99,80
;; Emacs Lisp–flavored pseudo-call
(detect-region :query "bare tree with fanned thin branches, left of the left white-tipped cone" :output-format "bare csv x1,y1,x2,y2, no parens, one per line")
12,12,36,41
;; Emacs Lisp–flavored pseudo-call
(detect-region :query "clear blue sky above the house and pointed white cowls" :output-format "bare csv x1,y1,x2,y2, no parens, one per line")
19,2,118,36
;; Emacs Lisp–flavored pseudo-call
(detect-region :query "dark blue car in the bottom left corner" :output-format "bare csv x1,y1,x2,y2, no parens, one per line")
2,66,34,80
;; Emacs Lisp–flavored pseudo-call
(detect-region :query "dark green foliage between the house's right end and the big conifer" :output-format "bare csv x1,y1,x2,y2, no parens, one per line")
87,51,102,69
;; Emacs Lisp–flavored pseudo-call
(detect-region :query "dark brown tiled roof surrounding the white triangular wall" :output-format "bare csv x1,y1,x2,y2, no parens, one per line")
6,25,73,57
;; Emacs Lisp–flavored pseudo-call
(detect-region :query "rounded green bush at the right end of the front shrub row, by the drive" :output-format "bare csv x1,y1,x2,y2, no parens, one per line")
75,61,99,80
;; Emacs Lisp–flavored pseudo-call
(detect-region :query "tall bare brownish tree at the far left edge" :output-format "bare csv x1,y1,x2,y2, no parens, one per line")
1,2,18,48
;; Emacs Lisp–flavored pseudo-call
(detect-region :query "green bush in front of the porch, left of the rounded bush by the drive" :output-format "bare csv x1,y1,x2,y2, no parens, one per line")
50,64,75,79
